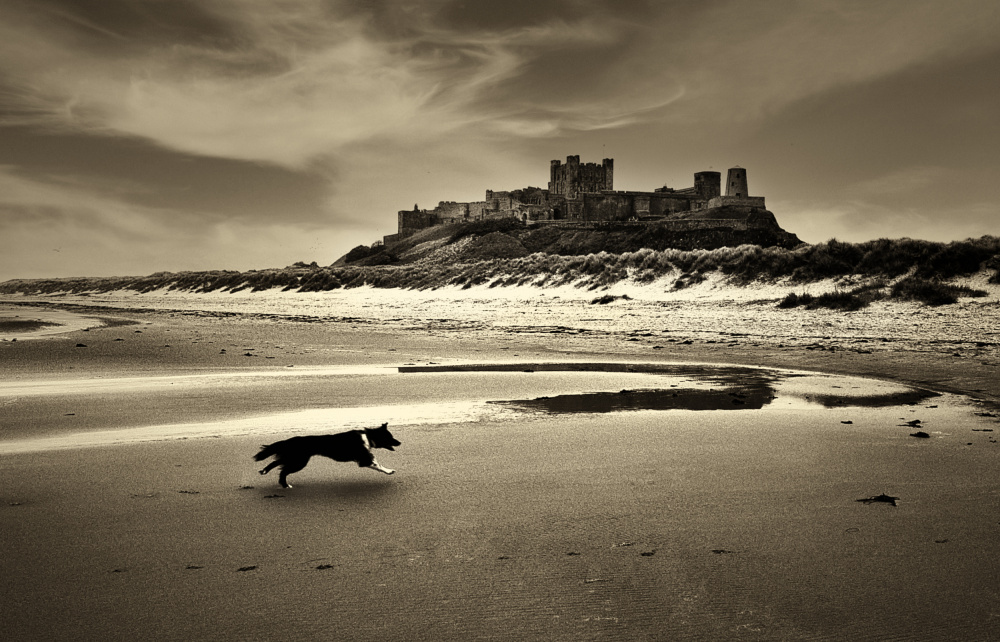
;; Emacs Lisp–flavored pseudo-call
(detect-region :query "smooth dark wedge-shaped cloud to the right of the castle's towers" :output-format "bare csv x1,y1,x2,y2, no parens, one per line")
748,51,1000,195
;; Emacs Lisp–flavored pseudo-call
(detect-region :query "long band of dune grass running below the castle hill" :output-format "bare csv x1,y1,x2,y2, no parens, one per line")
0,235,1000,310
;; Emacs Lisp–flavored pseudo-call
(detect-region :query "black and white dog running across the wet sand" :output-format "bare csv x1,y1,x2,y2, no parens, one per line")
253,424,400,488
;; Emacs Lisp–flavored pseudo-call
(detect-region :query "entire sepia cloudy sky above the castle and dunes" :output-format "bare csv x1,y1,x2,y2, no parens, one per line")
0,0,1000,281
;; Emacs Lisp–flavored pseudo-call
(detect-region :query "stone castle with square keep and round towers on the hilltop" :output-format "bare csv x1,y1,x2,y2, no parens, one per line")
384,156,777,246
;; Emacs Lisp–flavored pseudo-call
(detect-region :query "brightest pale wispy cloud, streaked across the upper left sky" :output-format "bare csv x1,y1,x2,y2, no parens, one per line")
0,2,632,166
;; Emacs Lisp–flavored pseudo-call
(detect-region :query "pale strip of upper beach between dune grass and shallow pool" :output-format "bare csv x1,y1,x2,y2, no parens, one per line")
0,293,1000,409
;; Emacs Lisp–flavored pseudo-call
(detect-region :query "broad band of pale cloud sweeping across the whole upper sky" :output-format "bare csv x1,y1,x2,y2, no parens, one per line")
0,0,996,167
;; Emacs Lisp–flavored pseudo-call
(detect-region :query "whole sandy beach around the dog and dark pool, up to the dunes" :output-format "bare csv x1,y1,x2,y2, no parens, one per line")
0,293,1000,640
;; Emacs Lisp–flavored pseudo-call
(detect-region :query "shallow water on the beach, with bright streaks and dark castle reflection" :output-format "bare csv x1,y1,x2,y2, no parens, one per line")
0,362,952,454
